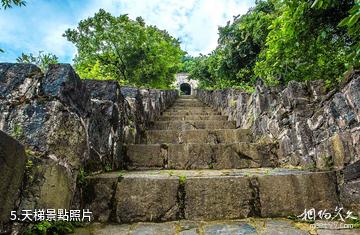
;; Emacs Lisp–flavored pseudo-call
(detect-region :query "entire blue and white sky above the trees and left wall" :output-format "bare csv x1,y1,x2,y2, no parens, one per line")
0,0,255,63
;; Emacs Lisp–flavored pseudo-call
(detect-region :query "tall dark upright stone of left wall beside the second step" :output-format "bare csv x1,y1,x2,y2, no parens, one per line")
83,80,127,171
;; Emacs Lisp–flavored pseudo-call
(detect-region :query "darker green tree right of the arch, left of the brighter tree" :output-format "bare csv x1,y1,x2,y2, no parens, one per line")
219,1,275,83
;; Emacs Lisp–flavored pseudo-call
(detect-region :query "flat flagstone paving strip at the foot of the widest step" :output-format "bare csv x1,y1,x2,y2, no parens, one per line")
75,218,320,235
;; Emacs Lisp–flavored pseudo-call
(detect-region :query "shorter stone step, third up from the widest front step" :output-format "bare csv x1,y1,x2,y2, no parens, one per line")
144,127,252,144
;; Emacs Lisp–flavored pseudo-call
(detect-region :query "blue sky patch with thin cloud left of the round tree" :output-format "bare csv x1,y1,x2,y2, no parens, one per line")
0,1,75,62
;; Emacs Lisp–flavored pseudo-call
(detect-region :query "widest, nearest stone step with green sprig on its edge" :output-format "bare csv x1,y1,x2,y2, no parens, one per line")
84,168,340,223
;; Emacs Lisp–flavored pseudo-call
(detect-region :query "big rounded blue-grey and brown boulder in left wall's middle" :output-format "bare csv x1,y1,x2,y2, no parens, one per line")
4,100,87,168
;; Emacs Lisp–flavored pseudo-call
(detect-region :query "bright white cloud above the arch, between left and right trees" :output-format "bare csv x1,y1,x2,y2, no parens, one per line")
83,0,254,55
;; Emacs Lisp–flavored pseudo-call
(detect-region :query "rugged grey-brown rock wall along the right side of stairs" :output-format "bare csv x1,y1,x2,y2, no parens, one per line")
197,71,360,172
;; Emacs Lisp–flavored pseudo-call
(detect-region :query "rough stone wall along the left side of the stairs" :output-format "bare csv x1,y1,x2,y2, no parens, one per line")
0,63,178,231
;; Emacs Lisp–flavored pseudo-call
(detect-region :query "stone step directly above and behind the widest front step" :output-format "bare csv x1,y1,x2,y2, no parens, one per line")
126,142,278,169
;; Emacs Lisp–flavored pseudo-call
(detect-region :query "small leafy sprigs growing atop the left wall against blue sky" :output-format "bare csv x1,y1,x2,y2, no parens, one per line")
16,51,58,72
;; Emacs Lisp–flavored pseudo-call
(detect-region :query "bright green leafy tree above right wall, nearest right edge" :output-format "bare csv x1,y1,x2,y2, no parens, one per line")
254,0,352,84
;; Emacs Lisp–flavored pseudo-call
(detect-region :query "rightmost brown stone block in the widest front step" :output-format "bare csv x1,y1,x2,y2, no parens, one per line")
258,172,339,217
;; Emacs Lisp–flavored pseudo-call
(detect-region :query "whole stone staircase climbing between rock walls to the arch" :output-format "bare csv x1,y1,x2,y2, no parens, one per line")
84,96,338,223
